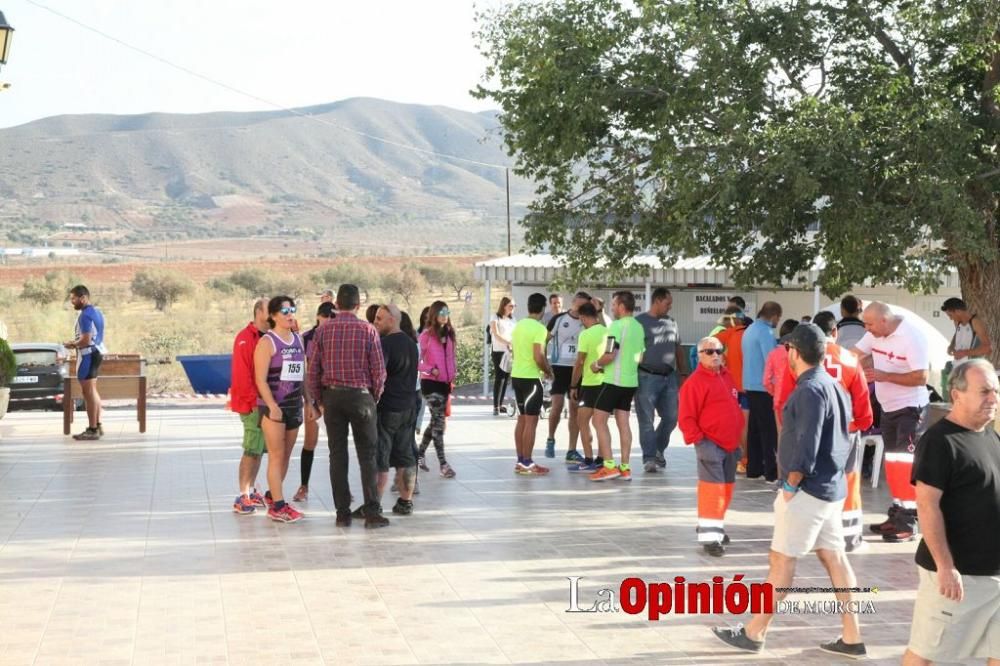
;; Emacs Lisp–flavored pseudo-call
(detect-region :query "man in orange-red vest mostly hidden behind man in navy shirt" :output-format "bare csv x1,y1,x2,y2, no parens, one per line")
774,311,874,553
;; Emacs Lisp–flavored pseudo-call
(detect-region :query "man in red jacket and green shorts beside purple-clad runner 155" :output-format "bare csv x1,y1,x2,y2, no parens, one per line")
229,298,268,514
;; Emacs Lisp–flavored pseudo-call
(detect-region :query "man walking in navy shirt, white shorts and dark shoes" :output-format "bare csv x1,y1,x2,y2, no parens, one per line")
712,324,867,659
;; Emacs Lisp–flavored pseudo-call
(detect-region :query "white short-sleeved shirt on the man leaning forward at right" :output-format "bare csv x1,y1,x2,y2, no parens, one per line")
854,318,930,412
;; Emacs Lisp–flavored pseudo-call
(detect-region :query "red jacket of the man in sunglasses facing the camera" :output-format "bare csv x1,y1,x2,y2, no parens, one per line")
677,365,743,451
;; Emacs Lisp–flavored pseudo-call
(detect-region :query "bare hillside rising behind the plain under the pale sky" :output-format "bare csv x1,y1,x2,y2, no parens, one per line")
0,98,532,255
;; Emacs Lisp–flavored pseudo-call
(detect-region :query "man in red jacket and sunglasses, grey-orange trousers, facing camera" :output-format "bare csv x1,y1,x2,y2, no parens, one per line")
677,338,743,557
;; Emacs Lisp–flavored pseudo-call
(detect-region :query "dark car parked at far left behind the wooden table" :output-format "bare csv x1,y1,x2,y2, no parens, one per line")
9,342,82,411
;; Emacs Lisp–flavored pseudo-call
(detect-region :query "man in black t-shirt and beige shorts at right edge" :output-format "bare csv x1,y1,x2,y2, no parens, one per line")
903,359,1000,664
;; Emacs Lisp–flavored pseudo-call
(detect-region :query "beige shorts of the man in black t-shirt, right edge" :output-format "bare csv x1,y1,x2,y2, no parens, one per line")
907,566,1000,662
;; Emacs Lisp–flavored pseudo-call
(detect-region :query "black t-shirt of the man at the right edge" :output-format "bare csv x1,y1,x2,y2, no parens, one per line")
911,418,1000,576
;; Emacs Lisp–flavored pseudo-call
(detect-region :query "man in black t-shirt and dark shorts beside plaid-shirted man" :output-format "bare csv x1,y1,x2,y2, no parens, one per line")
375,304,418,515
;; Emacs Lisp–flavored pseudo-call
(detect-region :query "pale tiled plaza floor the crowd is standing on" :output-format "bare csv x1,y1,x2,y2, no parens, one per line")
0,406,936,666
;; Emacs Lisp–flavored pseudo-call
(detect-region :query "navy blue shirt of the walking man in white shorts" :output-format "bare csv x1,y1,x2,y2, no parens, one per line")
778,366,852,502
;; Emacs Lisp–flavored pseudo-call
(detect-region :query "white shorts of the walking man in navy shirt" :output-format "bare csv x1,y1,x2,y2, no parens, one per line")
771,490,844,557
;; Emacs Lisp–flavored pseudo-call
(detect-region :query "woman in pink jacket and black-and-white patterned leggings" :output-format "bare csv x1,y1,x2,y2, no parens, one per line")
417,301,457,479
